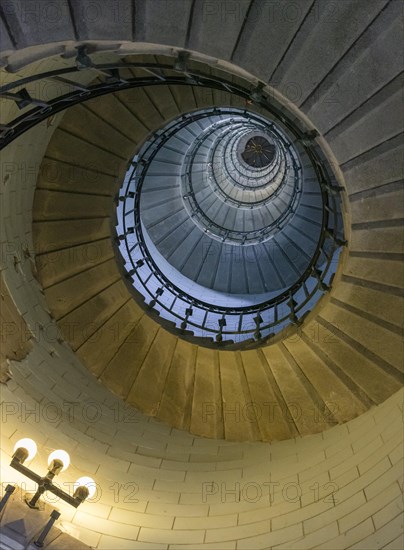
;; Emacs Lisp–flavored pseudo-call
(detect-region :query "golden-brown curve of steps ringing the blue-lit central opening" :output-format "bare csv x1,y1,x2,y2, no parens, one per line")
24,44,402,440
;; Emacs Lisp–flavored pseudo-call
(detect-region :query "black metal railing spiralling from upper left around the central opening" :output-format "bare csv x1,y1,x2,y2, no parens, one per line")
0,45,346,346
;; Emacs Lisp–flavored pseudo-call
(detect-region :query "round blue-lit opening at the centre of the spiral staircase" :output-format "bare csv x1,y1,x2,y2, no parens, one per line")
116,107,343,349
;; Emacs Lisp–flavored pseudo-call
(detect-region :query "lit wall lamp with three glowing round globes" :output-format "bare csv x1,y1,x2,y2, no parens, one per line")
4,438,96,511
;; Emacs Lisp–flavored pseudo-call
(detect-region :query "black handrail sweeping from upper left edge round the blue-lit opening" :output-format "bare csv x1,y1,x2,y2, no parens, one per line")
0,50,346,342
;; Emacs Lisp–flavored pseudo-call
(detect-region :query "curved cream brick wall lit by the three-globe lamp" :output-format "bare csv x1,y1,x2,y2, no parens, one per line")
1,344,403,550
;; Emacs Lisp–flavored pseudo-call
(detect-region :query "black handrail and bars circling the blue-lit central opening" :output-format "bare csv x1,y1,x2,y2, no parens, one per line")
115,109,342,345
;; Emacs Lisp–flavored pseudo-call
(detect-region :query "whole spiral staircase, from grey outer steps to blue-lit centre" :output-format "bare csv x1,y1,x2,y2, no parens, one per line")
1,0,404,548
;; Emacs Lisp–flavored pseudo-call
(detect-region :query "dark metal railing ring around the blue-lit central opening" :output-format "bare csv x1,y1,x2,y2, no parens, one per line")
117,109,344,347
